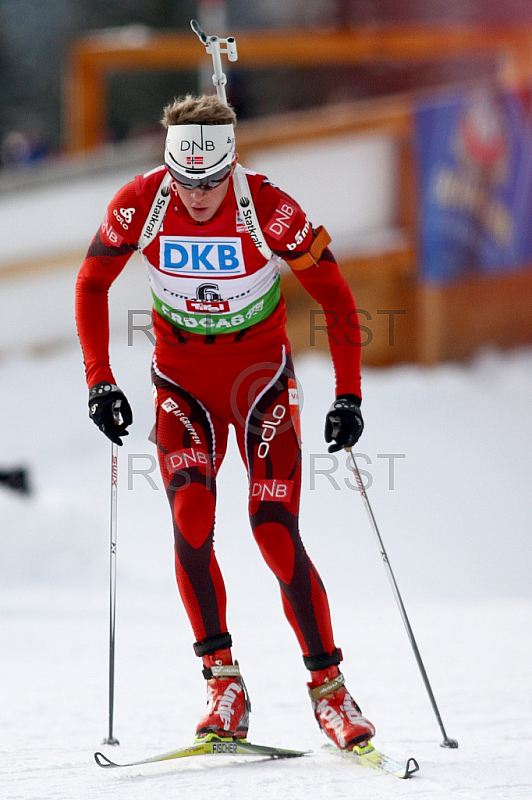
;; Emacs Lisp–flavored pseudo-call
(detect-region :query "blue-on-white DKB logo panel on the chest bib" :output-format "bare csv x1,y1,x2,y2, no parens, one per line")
159,236,246,277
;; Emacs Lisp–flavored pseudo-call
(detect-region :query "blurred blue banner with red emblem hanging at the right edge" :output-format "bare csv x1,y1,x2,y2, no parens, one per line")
415,85,532,282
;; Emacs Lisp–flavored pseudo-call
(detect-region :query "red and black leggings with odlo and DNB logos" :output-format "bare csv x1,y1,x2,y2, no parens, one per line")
153,344,335,656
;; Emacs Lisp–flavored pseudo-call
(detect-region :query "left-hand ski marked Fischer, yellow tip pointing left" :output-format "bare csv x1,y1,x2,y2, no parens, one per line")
94,733,308,768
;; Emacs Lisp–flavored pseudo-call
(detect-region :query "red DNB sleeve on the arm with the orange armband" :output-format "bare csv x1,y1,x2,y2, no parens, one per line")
257,181,362,398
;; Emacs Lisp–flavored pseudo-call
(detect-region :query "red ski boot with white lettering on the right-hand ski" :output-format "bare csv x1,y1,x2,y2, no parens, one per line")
307,666,375,750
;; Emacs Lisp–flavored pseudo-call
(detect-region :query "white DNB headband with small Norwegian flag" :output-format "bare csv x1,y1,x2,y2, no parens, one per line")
164,124,235,178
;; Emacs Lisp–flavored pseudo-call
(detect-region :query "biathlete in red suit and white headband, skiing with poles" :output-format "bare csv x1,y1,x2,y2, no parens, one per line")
76,95,375,749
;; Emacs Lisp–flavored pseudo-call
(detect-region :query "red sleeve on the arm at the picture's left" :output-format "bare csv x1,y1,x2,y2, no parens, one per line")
76,181,145,388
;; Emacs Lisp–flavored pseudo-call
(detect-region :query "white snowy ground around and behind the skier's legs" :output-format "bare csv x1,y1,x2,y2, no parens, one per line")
0,340,532,800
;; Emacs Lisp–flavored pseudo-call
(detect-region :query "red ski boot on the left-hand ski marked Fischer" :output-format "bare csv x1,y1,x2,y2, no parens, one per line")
196,649,251,739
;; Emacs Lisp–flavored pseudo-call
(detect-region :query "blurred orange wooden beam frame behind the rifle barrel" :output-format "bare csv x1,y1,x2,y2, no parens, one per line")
66,26,532,151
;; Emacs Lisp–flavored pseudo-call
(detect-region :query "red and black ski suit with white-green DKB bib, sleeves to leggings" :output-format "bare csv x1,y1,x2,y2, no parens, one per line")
76,166,361,663
